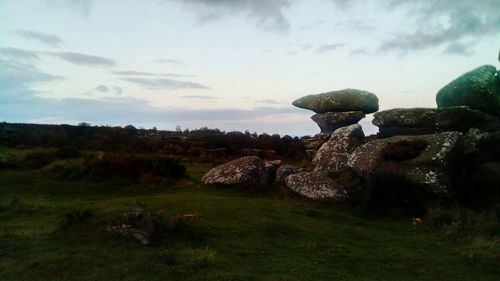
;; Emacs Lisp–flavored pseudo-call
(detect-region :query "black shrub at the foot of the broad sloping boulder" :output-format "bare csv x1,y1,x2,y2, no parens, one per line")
360,173,425,215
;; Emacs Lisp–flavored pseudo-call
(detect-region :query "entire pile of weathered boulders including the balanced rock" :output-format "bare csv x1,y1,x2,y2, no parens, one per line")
203,63,500,201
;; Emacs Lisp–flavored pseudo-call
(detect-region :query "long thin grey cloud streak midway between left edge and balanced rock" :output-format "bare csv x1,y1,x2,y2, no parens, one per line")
120,77,210,90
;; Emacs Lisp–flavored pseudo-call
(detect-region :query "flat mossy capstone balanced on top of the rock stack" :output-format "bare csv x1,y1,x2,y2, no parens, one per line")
292,89,378,113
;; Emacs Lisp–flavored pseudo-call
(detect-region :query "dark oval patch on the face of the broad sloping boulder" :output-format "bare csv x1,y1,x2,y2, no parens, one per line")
382,139,427,162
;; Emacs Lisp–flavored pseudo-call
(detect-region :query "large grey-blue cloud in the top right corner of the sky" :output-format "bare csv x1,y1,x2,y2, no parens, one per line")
378,0,500,55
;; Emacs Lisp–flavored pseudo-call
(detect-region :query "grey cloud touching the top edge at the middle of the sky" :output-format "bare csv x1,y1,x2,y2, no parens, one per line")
170,0,291,31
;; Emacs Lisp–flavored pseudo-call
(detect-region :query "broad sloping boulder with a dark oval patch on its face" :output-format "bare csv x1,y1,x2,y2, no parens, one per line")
348,132,463,196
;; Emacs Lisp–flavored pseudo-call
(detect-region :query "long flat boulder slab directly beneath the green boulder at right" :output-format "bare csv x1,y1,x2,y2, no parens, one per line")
372,106,500,137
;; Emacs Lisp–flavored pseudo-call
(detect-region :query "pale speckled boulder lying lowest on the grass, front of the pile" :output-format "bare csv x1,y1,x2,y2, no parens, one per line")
285,172,347,201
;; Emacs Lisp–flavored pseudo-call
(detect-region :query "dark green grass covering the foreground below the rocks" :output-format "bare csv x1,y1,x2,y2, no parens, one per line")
0,158,500,281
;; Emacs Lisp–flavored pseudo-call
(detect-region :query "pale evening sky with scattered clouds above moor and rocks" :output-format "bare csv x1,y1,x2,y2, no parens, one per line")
0,0,500,136
